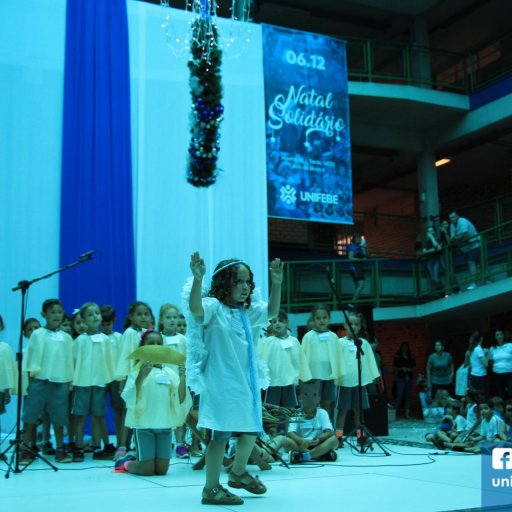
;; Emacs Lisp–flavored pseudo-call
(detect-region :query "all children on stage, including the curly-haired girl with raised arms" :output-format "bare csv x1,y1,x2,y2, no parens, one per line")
0,253,379,505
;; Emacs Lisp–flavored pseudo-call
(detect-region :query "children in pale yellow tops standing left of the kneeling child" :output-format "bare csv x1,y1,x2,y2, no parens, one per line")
0,299,188,465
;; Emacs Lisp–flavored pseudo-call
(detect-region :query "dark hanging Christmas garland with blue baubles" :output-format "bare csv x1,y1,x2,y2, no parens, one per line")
187,17,224,187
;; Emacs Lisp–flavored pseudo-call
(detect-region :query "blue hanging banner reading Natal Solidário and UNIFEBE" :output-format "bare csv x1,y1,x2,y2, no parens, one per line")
263,25,353,224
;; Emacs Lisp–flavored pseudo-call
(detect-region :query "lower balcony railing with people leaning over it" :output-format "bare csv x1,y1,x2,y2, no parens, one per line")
282,217,512,312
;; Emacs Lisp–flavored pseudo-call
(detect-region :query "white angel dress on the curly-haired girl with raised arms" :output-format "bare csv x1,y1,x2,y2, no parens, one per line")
187,297,268,432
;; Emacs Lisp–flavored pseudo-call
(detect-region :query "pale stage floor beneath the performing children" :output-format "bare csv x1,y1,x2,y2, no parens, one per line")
0,421,504,512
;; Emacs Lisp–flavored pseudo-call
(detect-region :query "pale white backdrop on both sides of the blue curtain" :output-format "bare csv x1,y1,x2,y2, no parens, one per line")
0,0,268,432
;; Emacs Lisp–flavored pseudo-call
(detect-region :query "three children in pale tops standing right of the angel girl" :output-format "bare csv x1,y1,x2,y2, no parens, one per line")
260,304,380,448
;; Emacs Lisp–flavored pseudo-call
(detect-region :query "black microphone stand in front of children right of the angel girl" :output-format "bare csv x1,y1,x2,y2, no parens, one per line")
324,267,391,456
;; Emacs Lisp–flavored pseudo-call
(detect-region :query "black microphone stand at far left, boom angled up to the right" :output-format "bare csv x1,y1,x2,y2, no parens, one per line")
0,251,94,478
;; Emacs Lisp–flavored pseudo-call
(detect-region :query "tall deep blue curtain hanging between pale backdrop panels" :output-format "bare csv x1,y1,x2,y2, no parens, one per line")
59,0,135,326
